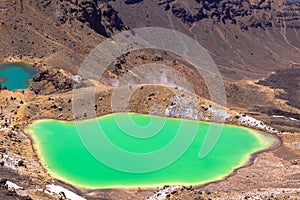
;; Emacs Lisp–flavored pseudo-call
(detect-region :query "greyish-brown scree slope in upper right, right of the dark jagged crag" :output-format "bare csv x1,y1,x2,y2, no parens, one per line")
112,0,300,79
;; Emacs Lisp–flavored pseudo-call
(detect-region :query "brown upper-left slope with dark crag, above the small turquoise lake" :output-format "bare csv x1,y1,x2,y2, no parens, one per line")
0,0,125,73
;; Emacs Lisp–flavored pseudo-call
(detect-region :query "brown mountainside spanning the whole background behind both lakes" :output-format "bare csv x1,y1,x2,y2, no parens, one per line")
0,0,300,80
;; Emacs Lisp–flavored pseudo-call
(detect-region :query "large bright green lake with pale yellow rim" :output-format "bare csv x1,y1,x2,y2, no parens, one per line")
27,113,276,188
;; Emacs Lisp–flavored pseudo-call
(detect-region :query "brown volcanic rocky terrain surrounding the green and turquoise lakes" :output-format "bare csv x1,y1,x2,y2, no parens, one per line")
0,0,300,199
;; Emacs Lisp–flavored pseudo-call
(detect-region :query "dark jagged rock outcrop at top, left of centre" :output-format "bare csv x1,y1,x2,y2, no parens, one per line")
36,0,125,37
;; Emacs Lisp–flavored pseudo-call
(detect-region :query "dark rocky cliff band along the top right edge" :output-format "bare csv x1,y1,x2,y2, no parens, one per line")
158,0,300,30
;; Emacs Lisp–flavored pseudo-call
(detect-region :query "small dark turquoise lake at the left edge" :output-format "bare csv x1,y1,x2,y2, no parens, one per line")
0,63,37,90
